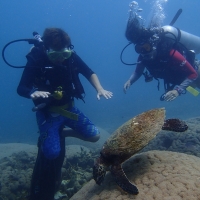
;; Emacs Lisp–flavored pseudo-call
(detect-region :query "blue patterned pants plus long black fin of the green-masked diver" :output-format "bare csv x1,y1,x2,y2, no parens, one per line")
29,107,99,200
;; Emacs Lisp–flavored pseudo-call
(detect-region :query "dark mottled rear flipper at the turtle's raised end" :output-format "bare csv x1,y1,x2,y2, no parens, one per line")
162,119,188,132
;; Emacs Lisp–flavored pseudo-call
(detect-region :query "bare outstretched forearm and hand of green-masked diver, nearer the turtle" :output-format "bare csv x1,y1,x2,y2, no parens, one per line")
89,74,113,100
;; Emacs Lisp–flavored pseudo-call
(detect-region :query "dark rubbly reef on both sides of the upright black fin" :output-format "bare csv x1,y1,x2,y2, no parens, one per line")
0,144,97,200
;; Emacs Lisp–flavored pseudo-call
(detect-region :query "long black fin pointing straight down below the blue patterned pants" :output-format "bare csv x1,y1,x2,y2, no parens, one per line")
29,139,65,200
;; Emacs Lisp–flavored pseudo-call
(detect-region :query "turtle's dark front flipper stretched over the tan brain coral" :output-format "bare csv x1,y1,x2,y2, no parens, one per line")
110,164,139,195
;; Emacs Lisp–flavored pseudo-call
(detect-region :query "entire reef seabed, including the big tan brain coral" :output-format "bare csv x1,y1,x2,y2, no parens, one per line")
0,117,200,200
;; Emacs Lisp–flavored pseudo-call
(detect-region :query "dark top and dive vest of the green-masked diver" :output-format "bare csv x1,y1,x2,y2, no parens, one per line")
17,47,94,105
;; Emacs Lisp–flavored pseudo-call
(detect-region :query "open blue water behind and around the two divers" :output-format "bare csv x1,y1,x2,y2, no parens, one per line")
0,0,200,144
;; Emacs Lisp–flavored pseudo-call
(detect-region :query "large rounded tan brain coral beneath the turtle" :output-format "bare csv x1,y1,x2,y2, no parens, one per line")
70,151,200,200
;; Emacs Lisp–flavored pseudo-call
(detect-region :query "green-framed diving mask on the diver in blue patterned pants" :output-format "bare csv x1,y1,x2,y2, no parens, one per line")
47,48,72,63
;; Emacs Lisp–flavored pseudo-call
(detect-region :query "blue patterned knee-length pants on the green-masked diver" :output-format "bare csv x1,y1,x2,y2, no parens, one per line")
36,107,99,159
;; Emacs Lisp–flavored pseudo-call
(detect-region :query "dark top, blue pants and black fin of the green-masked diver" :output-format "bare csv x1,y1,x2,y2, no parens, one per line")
17,48,99,200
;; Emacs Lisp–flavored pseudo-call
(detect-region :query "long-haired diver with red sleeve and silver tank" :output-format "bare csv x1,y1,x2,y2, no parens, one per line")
121,2,200,101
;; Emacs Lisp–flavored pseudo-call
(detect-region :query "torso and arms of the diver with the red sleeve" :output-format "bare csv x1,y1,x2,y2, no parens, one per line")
124,38,198,101
